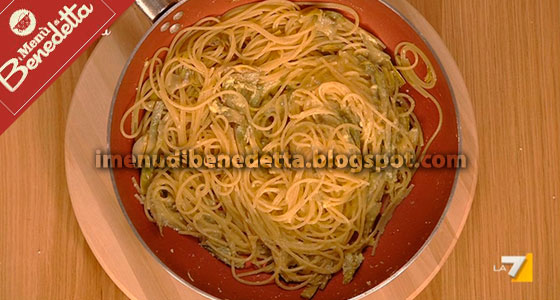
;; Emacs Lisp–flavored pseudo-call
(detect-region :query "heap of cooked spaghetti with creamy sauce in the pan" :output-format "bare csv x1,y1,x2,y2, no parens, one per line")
120,0,442,298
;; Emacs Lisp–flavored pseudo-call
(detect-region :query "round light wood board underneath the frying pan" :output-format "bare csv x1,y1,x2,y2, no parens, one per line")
65,0,478,299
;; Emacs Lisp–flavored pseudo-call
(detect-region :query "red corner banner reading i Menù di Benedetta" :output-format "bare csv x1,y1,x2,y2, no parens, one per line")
0,0,133,134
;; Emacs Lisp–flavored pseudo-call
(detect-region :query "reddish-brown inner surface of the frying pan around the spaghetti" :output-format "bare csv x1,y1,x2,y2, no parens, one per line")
109,0,459,300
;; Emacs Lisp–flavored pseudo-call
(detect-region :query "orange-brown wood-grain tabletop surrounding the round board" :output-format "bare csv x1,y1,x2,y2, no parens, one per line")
0,0,560,300
